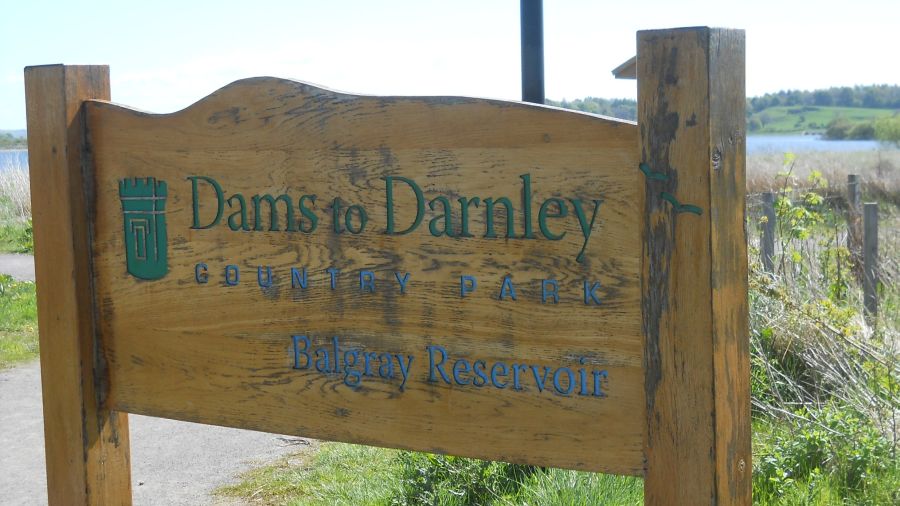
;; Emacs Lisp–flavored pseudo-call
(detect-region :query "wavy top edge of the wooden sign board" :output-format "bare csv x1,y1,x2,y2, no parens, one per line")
86,76,637,125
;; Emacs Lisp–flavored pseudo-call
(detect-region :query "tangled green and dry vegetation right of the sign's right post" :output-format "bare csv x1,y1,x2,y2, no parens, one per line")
750,156,900,505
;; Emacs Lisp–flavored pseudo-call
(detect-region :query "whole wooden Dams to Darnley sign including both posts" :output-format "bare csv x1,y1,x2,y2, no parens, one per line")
26,29,750,504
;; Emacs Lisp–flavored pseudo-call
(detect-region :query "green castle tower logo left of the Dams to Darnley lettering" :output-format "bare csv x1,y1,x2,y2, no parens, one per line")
119,177,169,280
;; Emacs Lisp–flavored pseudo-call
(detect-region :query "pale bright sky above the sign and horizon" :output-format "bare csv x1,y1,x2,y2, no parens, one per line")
0,0,900,129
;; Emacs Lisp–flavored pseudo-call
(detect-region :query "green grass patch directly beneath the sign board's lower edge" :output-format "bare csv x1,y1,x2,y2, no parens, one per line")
217,443,644,506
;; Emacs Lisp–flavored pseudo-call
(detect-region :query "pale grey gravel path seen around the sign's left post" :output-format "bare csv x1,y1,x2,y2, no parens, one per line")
0,254,305,506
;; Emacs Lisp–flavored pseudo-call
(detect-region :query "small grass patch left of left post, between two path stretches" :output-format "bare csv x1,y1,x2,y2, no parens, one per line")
0,274,38,369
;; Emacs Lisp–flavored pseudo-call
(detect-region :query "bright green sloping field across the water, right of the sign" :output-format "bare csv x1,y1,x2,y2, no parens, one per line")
750,106,897,134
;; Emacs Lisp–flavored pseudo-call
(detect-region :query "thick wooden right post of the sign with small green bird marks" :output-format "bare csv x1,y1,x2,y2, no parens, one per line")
637,28,752,505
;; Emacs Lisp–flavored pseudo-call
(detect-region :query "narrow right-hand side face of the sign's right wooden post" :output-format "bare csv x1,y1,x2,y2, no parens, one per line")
707,29,753,505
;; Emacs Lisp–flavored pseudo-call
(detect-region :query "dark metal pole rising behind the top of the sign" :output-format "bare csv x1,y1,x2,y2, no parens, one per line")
520,0,544,104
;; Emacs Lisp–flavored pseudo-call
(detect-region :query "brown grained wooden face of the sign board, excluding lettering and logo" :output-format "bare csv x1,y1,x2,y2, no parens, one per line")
87,78,648,474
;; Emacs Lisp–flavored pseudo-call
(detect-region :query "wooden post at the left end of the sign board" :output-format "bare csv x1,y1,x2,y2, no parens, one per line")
25,65,131,505
